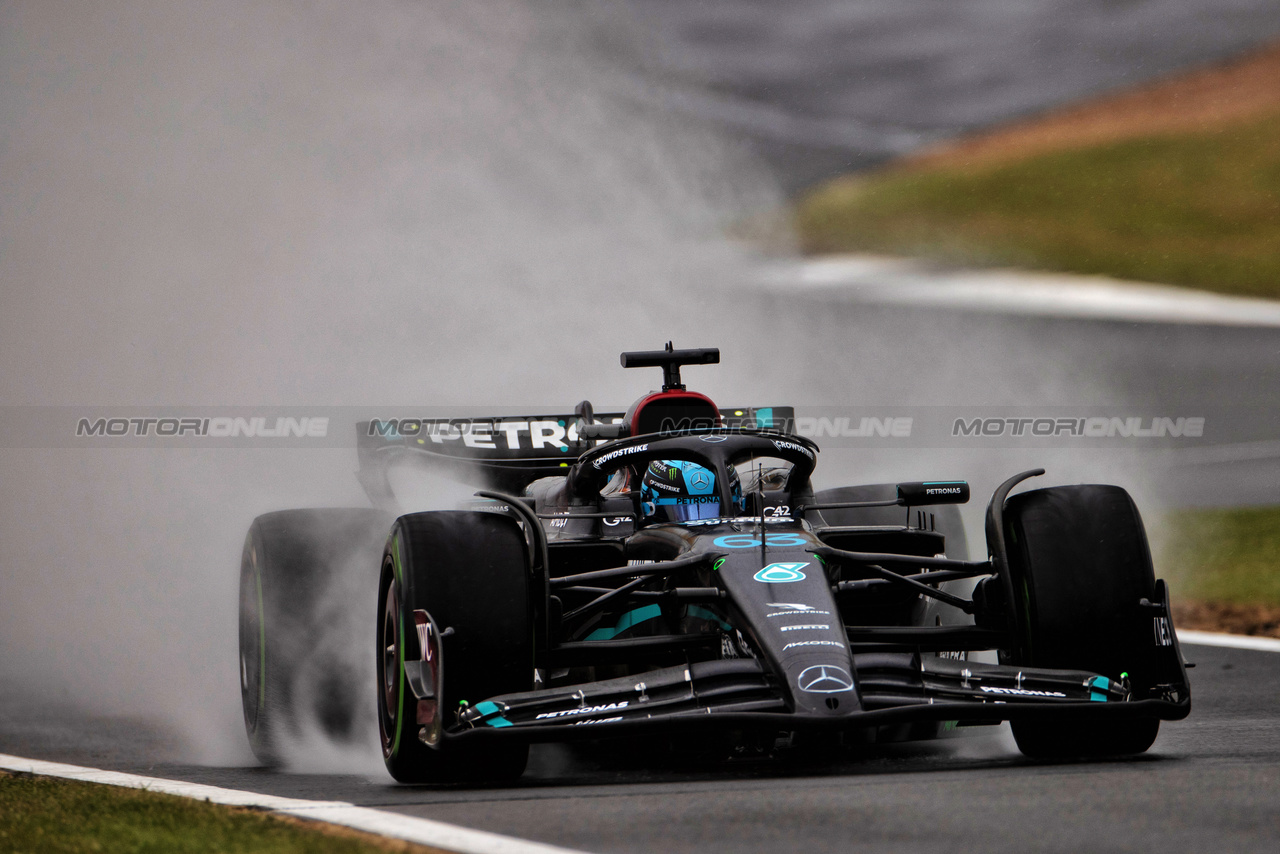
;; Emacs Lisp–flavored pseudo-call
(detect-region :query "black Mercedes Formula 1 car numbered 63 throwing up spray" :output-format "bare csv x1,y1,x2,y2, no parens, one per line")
241,344,1190,782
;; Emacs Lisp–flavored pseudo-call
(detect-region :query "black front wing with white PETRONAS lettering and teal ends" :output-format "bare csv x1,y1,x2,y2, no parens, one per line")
444,653,1190,741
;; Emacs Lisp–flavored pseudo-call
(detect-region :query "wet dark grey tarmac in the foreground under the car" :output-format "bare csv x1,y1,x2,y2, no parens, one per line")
0,647,1280,853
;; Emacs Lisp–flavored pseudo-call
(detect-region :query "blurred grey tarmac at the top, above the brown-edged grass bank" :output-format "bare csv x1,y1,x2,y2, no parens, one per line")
626,0,1280,189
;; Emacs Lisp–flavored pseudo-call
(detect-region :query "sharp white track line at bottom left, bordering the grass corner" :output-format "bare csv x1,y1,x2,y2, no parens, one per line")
0,753,581,854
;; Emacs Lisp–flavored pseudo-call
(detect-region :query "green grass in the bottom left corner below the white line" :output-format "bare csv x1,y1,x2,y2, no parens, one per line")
0,773,414,854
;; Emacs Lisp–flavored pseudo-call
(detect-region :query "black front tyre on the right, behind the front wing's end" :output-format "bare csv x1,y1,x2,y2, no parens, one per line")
1002,484,1160,759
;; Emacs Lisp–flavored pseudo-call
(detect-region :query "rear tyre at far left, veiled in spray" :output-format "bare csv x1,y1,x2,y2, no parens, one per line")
239,508,390,764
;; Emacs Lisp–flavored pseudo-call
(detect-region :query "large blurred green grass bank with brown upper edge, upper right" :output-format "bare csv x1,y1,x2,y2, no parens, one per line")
796,114,1280,297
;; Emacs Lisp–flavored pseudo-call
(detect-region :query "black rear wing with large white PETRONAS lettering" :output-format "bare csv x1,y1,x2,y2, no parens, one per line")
356,406,795,510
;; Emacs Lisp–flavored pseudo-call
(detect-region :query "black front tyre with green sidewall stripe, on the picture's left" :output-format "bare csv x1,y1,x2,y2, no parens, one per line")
378,511,534,782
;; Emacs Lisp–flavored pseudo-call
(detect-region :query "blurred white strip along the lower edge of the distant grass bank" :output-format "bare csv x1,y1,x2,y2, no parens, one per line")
764,255,1280,326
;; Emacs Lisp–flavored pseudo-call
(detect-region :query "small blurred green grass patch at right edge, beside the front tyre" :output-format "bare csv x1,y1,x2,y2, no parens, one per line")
1158,507,1280,606
